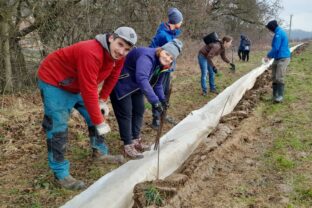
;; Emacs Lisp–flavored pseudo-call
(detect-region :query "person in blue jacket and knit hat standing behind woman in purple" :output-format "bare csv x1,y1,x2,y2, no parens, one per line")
149,8,183,129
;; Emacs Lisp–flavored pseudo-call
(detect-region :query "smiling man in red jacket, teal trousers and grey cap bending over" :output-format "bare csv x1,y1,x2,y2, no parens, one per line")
38,27,137,189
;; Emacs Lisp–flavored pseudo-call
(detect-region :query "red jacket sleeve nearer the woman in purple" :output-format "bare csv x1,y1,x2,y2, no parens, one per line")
100,58,125,100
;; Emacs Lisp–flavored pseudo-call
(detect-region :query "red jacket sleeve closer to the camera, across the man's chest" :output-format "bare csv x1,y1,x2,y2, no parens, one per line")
77,49,104,125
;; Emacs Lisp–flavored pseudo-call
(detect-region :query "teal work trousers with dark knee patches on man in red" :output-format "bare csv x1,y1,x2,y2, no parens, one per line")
38,80,108,179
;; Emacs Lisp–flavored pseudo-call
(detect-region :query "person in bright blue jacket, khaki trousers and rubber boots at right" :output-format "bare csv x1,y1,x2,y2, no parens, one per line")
264,20,290,103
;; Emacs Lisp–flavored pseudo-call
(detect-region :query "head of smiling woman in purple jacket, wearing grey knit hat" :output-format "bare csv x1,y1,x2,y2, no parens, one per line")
156,39,183,66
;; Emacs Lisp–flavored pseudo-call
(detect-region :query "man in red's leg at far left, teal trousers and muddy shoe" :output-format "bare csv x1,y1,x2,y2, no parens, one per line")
39,80,84,189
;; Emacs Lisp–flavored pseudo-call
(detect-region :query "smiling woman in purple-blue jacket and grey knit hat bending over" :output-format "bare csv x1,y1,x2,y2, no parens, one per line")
110,39,183,159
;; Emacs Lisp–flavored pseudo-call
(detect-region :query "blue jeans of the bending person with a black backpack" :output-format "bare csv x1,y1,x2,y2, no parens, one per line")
198,53,216,93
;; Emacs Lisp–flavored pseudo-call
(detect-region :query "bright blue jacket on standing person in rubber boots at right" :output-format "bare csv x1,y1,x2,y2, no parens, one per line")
267,26,290,59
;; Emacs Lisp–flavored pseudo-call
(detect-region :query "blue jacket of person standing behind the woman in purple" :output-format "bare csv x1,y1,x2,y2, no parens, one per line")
149,22,181,48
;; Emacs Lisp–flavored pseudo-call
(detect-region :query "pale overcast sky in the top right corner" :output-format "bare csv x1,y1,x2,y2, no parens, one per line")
279,0,312,32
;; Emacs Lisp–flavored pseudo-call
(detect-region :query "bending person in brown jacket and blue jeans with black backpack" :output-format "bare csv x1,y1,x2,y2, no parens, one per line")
198,36,235,96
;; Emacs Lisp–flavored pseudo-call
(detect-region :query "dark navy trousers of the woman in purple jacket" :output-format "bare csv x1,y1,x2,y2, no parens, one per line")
110,90,145,145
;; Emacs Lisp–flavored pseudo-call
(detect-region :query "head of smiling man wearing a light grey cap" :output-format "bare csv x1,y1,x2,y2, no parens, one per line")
108,27,137,60
